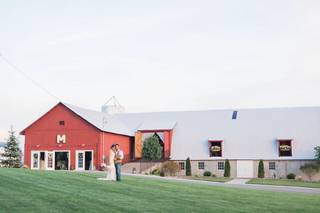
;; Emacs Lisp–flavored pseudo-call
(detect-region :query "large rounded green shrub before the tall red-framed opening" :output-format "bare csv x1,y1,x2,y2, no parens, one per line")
142,136,162,160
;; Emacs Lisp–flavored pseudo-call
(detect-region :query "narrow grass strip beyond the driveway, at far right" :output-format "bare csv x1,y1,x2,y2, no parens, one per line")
247,179,320,188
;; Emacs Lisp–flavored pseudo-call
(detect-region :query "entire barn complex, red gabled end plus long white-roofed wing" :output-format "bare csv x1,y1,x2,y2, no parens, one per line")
22,103,320,178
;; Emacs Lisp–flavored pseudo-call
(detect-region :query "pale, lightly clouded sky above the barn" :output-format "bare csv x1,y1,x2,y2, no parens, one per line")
0,0,320,141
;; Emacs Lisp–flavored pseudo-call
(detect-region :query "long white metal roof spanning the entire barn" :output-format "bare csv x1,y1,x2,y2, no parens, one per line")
65,104,320,160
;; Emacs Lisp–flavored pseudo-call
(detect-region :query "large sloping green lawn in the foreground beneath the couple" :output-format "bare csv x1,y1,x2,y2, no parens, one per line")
0,169,320,213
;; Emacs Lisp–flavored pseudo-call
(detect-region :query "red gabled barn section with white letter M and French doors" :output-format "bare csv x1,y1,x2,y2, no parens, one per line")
21,103,172,170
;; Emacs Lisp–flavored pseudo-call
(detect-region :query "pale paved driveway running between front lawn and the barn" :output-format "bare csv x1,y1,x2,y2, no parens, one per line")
123,174,320,195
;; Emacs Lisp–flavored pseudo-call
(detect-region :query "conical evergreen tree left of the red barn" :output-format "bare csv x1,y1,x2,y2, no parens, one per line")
1,127,21,168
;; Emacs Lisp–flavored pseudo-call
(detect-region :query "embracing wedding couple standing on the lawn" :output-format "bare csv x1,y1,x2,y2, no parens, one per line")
106,144,124,181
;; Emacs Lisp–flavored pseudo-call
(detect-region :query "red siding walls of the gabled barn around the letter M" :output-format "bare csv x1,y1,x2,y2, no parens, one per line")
22,103,130,169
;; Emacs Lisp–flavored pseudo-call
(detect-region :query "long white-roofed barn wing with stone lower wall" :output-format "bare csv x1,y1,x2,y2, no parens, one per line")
116,107,320,178
